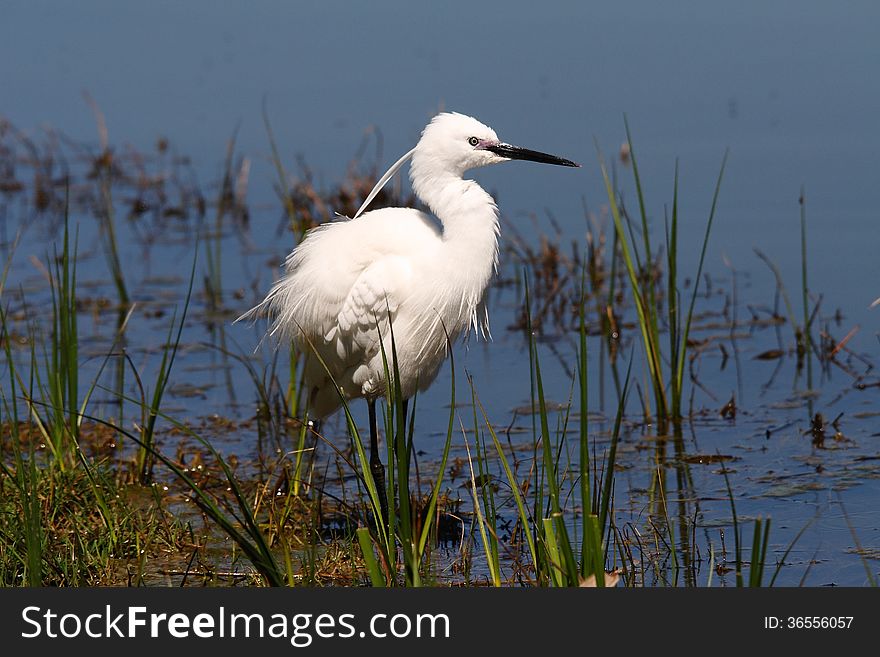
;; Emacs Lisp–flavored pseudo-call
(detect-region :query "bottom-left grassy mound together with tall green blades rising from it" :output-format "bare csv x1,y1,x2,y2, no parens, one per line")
0,226,196,586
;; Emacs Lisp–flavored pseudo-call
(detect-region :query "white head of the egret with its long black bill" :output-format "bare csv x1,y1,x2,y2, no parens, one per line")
413,112,580,176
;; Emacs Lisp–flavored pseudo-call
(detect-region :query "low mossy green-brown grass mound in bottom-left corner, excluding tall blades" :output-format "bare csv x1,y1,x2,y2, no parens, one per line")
0,446,192,586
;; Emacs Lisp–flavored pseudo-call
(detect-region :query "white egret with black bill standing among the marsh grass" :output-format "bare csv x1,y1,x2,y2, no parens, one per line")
239,113,580,517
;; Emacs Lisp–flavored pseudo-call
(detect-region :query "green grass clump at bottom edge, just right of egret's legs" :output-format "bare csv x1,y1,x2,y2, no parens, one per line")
472,276,629,587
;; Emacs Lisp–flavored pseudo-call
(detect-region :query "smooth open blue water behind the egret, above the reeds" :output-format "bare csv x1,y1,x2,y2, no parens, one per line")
6,1,880,280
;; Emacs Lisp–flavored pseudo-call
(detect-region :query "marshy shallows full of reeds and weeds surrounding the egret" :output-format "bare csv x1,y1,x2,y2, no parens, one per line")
0,109,880,586
